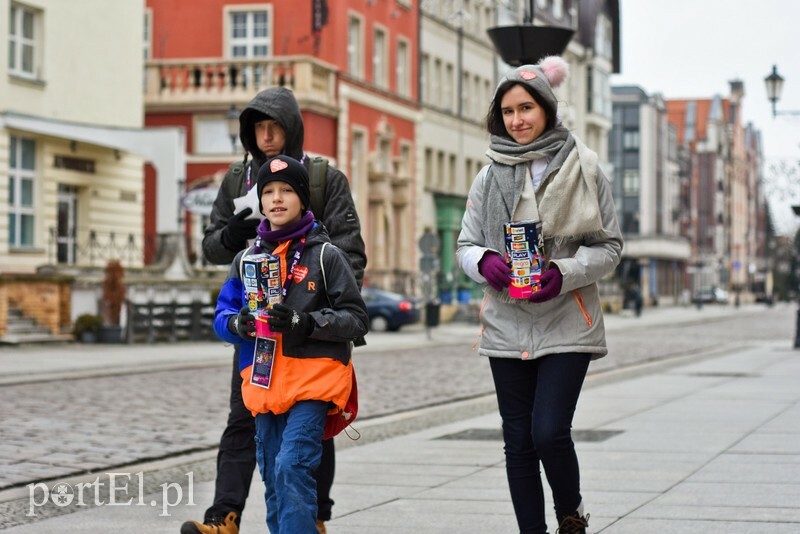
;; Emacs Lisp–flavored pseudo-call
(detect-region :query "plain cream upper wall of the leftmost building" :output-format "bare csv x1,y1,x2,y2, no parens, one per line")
0,0,144,128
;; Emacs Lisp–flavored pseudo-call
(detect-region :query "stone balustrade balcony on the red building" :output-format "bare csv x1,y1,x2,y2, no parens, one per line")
144,56,337,116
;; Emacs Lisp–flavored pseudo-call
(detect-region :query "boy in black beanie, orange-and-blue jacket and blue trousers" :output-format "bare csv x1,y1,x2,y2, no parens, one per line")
214,155,369,534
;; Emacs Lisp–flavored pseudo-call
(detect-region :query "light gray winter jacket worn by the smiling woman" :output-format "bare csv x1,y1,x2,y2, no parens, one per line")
457,158,622,359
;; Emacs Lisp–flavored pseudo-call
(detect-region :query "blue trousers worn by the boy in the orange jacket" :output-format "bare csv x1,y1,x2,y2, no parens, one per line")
255,401,328,534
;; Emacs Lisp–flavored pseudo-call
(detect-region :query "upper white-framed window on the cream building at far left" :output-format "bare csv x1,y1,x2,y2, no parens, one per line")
8,4,41,78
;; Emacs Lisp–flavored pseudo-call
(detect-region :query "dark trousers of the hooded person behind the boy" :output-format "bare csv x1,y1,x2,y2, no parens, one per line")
205,347,336,521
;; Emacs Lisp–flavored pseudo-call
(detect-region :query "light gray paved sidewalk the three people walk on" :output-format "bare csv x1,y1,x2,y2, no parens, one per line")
7,307,800,534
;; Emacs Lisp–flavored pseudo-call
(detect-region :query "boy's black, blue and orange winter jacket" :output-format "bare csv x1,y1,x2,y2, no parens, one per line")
214,222,369,415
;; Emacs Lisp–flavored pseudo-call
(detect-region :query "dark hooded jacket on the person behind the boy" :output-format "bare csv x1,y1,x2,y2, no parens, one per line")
203,87,367,287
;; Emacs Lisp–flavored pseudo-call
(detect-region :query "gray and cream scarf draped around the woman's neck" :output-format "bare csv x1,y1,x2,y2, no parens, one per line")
482,127,604,251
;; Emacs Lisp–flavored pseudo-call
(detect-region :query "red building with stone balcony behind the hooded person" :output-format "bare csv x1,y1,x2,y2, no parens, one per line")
144,0,419,289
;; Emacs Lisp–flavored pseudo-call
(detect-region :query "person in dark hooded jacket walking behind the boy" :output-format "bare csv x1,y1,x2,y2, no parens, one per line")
181,87,367,534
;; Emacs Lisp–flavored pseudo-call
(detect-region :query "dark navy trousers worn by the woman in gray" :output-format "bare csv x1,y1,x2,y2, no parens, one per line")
489,353,591,534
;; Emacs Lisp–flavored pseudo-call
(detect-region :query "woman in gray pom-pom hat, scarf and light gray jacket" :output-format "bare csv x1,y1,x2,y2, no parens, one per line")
457,57,622,534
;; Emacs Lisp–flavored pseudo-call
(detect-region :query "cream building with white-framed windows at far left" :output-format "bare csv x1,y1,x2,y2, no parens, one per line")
0,0,181,337
